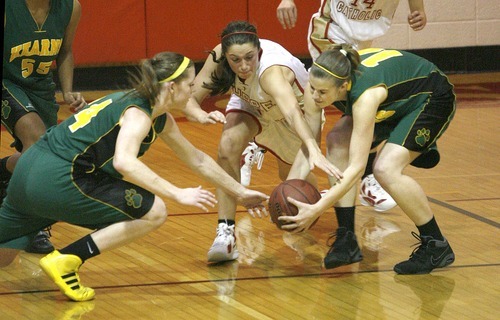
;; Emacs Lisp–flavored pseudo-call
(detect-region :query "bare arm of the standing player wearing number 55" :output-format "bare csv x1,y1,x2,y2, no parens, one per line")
56,0,86,111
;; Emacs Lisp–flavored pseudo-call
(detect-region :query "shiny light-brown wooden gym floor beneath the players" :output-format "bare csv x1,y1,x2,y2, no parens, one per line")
0,73,500,320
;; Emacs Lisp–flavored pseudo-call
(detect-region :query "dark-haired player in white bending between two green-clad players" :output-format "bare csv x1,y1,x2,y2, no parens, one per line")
186,21,340,262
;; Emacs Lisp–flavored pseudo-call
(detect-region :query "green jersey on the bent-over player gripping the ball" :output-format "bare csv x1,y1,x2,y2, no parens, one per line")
335,48,453,123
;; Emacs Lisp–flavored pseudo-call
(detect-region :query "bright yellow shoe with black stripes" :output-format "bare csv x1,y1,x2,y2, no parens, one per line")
40,250,95,301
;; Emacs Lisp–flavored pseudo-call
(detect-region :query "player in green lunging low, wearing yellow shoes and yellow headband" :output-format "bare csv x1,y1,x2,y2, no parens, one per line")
0,52,267,301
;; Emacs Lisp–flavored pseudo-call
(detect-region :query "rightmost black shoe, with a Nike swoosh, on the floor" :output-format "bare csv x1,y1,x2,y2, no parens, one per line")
394,232,455,274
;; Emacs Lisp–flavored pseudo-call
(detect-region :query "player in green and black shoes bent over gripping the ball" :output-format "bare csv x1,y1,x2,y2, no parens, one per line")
279,44,455,274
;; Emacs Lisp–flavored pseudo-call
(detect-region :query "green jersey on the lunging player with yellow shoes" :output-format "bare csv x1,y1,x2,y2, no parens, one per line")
38,92,167,178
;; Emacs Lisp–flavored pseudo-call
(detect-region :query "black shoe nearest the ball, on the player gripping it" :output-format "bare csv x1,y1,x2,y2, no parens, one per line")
324,227,363,269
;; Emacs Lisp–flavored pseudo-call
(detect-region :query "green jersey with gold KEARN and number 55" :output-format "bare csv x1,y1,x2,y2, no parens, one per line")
3,0,73,100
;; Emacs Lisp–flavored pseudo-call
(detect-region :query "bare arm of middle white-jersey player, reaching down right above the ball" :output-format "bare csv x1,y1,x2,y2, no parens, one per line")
260,66,340,177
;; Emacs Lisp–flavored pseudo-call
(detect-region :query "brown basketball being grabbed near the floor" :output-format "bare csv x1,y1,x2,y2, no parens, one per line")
269,179,321,229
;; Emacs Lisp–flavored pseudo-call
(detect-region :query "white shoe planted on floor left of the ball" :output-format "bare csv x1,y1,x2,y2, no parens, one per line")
208,222,239,262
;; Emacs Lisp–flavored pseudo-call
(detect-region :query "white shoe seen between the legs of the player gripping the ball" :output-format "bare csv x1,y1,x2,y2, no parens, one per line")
359,174,397,212
